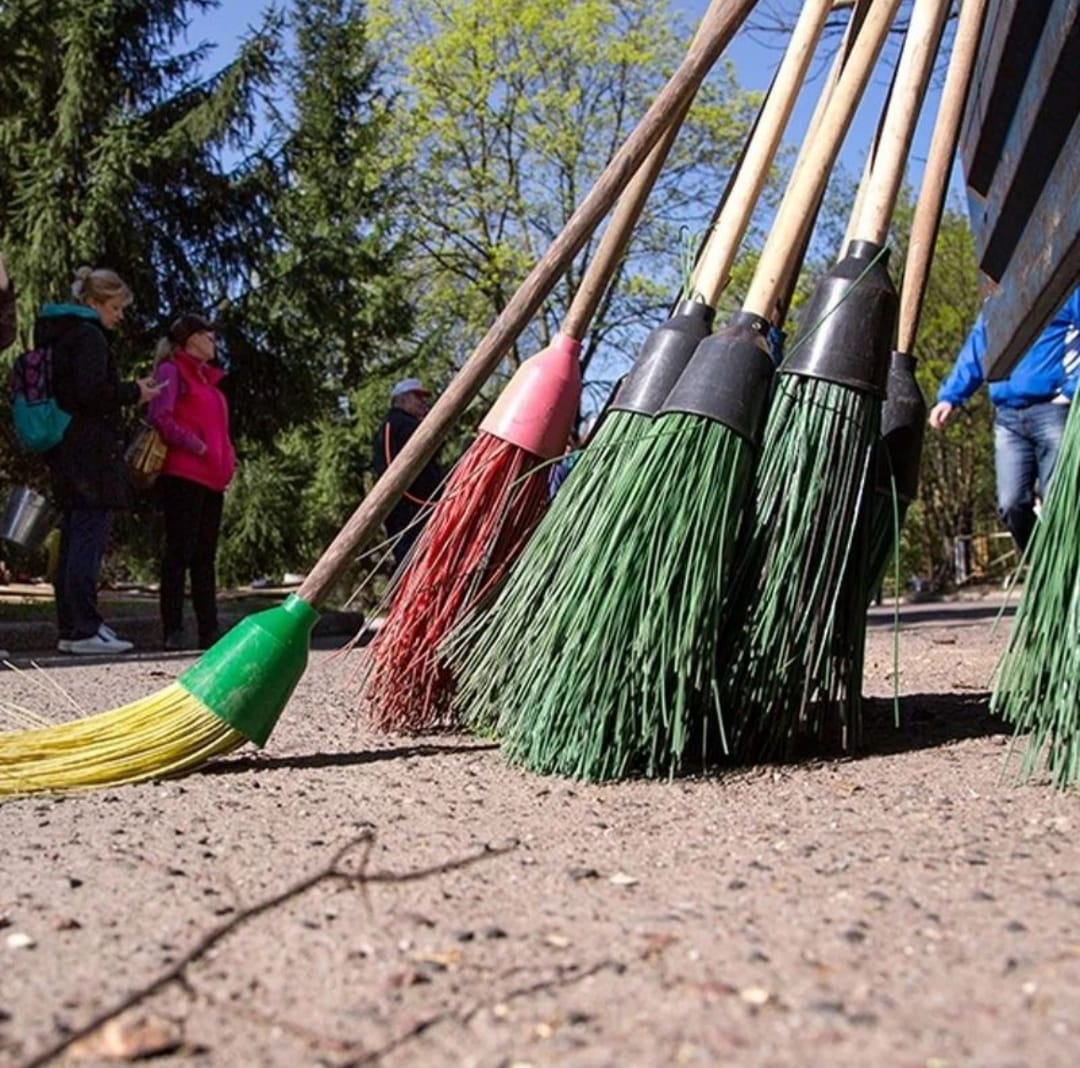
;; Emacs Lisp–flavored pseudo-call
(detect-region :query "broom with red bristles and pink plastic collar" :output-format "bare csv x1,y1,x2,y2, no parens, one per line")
364,39,708,733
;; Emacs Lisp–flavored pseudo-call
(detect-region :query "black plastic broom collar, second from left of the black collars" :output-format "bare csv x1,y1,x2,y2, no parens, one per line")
660,311,773,448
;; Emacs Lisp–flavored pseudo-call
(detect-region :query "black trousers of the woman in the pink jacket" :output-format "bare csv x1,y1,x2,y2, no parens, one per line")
158,475,225,644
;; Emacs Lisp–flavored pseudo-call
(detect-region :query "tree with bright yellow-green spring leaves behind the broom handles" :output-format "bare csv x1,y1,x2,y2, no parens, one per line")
370,0,756,414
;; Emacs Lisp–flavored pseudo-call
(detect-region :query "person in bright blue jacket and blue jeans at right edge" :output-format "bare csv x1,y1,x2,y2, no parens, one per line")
930,288,1080,552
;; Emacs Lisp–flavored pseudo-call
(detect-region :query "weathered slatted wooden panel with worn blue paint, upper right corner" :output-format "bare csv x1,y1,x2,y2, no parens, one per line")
961,0,1080,378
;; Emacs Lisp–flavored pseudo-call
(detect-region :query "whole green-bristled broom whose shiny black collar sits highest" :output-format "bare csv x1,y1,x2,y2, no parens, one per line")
725,0,947,760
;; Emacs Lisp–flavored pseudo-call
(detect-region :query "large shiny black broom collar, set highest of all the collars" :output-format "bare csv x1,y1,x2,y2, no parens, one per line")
780,241,900,398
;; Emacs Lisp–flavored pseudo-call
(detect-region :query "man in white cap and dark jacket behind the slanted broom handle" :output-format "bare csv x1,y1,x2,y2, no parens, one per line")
372,378,443,565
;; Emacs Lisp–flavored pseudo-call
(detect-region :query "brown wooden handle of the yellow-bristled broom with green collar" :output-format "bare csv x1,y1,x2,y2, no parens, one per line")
297,0,756,606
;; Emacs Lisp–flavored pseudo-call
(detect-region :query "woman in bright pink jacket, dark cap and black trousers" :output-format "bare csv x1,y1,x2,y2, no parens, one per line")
149,314,237,649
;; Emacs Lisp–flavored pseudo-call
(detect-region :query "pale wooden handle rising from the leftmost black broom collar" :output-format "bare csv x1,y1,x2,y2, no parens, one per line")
693,0,833,308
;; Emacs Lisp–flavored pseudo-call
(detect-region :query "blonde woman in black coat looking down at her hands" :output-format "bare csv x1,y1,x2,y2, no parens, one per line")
33,267,161,654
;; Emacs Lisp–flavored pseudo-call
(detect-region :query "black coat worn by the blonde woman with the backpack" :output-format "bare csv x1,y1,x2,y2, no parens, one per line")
33,305,139,509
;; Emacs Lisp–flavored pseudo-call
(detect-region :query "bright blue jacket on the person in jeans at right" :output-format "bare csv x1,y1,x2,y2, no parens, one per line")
937,288,1080,408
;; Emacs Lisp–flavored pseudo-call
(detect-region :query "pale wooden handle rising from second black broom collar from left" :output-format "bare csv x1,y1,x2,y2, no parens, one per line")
743,0,900,319
